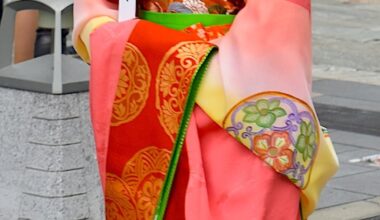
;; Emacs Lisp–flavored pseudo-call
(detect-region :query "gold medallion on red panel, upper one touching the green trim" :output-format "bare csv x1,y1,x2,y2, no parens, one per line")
156,41,212,141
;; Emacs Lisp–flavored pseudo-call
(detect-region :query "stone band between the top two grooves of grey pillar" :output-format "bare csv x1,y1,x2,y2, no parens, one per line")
29,118,82,146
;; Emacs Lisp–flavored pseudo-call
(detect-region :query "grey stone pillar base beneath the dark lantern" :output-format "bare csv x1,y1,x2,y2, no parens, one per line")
0,88,103,220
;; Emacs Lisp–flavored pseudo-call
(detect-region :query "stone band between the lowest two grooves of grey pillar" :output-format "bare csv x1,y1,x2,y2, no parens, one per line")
22,169,87,198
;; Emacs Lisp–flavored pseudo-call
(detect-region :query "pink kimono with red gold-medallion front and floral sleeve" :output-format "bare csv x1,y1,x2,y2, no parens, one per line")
73,0,338,220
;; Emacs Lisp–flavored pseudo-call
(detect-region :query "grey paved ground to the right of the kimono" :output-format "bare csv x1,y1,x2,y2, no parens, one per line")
310,0,380,220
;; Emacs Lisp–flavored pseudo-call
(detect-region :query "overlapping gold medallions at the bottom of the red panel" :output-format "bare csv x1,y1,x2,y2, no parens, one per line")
105,147,170,220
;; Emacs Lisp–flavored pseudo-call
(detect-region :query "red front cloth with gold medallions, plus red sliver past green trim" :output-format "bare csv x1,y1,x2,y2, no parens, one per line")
105,21,212,219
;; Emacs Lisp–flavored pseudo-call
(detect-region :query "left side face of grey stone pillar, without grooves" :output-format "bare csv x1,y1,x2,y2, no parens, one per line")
0,88,33,220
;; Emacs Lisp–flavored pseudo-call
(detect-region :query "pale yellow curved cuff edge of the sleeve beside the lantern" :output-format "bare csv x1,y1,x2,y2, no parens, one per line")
74,16,115,63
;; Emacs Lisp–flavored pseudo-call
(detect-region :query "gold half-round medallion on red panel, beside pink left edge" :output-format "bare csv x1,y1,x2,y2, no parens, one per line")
111,43,151,126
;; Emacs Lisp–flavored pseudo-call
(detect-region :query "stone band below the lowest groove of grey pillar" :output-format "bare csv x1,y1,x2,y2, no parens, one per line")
20,194,90,220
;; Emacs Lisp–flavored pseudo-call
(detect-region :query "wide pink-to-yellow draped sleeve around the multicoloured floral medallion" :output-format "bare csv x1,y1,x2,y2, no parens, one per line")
197,0,339,218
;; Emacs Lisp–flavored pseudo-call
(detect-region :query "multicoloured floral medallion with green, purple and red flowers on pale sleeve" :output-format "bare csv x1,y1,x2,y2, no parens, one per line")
223,92,320,188
